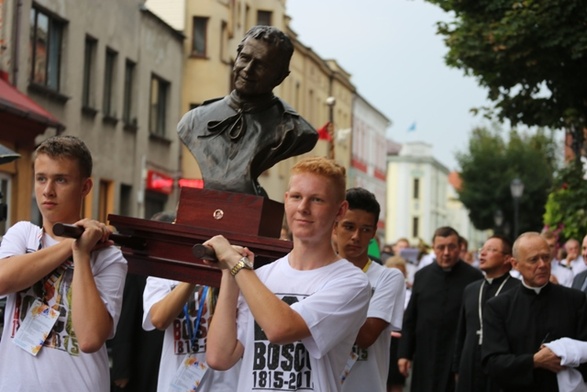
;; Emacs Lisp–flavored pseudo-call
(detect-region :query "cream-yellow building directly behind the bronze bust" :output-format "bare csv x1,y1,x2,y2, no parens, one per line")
146,0,355,201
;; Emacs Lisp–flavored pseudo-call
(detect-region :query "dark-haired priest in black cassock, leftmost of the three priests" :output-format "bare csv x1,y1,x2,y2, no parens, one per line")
398,227,483,392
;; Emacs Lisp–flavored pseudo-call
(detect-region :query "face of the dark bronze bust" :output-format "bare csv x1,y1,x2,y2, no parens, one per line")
232,37,282,95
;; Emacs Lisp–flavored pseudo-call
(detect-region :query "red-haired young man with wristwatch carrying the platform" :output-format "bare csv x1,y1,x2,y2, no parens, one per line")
206,158,371,392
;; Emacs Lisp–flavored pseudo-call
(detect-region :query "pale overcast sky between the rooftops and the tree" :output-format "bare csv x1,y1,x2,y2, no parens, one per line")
287,0,488,170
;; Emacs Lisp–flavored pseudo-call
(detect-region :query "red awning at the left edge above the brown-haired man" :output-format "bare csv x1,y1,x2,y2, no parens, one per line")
0,72,65,146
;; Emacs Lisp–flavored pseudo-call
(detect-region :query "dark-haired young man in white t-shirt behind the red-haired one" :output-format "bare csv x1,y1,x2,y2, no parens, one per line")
332,188,405,392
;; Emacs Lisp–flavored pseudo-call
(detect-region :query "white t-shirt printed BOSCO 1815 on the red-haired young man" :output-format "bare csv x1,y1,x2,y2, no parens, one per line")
237,255,371,392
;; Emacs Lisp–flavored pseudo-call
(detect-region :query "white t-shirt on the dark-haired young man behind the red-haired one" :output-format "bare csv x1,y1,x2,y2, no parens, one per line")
342,263,406,392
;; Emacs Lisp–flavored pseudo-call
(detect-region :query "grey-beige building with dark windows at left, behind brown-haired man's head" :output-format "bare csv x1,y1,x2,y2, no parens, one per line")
0,0,184,230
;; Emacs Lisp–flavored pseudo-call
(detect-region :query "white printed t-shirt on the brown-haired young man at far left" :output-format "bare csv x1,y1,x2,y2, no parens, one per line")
0,222,127,392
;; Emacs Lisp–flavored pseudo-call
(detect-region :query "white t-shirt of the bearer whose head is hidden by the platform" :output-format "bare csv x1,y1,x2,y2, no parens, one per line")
143,276,240,392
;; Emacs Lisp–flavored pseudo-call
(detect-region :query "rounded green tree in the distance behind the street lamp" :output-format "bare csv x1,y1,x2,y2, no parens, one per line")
456,126,559,240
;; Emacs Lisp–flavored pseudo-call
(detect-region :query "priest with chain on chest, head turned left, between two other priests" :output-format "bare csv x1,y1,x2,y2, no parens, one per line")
453,235,520,392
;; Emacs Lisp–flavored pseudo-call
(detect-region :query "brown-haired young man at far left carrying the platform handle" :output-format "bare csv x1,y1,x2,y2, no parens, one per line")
0,136,127,392
